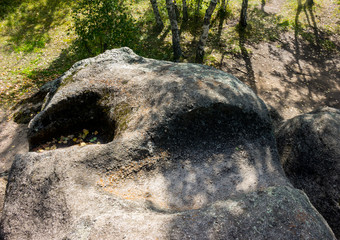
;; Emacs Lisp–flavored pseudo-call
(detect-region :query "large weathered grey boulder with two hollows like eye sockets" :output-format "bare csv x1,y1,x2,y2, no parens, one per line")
1,48,335,240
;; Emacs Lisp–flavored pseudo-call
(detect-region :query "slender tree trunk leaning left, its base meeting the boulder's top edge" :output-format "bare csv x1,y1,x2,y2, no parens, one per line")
166,0,182,61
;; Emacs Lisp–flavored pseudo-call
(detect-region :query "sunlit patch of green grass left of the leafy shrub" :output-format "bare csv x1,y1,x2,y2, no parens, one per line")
0,0,74,107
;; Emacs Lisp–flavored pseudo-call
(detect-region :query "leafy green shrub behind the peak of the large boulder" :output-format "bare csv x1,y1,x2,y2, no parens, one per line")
73,0,137,55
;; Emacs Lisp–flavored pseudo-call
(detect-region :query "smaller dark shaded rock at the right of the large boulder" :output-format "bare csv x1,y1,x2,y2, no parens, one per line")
277,107,340,239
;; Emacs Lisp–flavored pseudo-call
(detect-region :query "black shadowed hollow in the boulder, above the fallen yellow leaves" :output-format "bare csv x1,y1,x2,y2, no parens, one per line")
28,92,115,150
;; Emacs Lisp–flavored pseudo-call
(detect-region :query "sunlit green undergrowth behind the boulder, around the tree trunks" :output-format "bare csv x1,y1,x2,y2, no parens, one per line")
0,0,340,107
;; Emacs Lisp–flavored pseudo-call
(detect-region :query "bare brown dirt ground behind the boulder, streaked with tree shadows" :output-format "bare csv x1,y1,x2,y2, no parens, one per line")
221,0,340,119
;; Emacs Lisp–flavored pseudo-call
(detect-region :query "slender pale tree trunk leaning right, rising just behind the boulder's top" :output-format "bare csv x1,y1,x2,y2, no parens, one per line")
196,0,217,63
